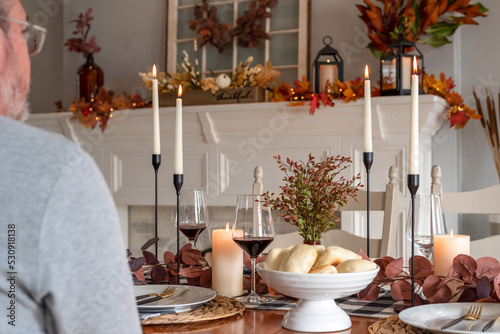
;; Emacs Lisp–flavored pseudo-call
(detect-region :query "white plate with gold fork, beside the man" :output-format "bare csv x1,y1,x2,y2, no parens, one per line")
134,284,217,313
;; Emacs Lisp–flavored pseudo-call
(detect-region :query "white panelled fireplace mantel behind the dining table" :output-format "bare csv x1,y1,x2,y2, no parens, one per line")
28,95,446,247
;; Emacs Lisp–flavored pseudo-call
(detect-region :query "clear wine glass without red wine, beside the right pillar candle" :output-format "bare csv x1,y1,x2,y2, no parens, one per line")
406,194,448,258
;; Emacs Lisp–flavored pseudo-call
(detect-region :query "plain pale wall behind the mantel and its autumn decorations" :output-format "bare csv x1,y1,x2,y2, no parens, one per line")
21,0,500,239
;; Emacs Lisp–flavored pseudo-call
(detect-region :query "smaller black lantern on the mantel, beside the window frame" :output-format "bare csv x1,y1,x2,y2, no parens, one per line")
313,36,344,93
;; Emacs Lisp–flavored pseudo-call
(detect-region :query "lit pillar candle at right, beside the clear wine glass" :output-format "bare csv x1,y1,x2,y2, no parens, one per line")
434,230,470,276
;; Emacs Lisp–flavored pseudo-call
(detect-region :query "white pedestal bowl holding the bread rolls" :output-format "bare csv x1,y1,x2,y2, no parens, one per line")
257,262,379,332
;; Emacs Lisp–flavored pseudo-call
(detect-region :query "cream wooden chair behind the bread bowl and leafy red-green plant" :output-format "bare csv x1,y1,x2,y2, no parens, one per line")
254,166,399,257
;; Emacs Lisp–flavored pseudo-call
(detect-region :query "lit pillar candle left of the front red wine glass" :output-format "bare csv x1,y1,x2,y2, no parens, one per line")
212,224,243,297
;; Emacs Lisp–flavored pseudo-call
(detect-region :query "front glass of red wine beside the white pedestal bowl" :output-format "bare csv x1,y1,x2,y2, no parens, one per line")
233,195,274,304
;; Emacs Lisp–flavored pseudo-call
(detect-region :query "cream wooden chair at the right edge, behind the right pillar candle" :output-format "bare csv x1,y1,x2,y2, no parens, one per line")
431,166,500,260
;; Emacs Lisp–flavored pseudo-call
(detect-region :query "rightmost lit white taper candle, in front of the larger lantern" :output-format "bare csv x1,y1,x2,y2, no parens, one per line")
408,57,419,174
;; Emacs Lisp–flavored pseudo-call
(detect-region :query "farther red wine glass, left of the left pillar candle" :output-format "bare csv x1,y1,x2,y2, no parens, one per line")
179,189,208,249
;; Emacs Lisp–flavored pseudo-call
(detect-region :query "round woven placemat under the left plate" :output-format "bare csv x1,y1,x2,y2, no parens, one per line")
141,296,245,325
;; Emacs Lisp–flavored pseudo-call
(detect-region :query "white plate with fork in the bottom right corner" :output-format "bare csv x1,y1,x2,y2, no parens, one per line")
399,303,500,334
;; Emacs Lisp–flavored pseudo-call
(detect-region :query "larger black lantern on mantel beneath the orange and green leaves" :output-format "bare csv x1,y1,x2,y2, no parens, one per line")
380,38,424,95
